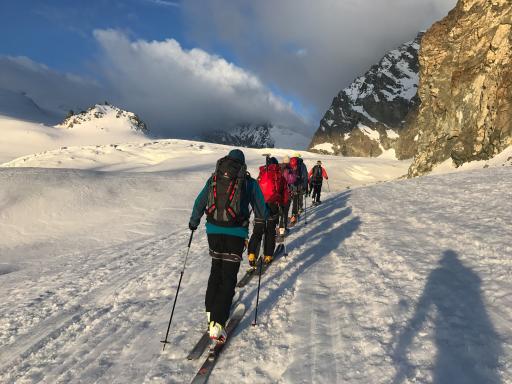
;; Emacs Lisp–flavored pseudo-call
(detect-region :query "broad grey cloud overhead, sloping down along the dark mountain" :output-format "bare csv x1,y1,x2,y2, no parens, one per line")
182,0,456,118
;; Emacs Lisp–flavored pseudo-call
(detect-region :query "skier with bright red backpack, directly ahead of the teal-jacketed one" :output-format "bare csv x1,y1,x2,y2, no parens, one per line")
247,157,288,266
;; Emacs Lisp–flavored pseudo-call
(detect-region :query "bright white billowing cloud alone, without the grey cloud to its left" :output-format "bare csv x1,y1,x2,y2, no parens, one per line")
94,30,305,137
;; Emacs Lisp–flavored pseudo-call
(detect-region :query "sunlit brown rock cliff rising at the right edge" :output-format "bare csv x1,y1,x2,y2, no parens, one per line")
409,0,512,176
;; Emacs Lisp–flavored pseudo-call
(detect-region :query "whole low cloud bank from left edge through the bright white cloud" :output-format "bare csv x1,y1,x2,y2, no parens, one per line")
0,30,306,138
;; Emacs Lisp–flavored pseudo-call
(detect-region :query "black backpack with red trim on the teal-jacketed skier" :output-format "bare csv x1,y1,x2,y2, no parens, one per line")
205,156,249,227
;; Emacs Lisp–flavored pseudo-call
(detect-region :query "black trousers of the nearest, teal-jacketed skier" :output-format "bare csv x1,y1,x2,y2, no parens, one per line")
204,235,245,326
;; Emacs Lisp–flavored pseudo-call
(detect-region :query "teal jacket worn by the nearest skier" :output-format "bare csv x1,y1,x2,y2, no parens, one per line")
190,175,268,239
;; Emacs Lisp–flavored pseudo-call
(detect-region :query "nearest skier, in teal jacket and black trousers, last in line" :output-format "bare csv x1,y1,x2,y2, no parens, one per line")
189,149,267,342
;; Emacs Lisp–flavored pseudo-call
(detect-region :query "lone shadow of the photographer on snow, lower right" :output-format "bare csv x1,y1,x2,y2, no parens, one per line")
393,250,502,384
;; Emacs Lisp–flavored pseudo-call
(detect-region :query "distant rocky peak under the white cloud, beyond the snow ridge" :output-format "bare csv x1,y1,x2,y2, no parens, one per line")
202,123,309,149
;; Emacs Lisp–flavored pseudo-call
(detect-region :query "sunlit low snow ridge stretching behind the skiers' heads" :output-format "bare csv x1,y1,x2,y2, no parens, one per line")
0,140,410,190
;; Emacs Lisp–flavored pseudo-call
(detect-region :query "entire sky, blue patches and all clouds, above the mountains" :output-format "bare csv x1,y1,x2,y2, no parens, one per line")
0,0,456,137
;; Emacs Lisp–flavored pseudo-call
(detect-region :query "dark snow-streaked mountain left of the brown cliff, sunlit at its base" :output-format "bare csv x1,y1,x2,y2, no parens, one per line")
309,33,422,159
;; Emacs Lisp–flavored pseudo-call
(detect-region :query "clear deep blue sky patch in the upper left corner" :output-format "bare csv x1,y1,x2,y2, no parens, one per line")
0,0,190,72
